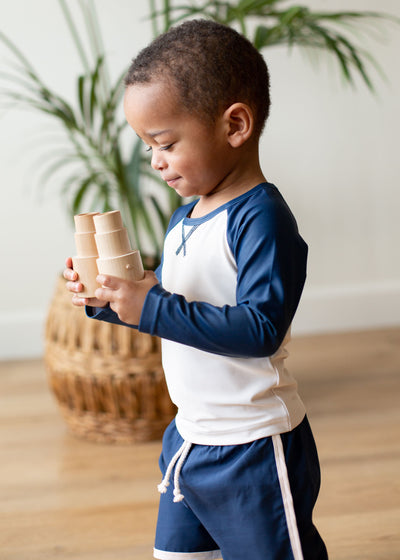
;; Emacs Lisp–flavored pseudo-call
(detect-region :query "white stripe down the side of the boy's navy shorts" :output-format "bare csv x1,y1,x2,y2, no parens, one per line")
272,435,303,560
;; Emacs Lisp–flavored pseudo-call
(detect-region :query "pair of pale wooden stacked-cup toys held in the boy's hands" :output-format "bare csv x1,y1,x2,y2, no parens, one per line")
72,210,144,297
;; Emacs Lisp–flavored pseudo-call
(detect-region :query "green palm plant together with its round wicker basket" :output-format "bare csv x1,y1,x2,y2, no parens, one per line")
0,0,394,442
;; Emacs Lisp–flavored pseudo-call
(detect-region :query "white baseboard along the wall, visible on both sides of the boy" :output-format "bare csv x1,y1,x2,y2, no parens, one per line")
0,283,400,360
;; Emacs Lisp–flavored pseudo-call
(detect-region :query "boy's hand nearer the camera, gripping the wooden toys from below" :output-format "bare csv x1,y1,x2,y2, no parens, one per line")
96,270,158,325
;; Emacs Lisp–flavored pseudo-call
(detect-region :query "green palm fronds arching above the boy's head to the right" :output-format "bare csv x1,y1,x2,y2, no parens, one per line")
151,0,399,91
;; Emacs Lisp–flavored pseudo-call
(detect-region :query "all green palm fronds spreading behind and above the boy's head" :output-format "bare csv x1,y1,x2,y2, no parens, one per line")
0,0,399,262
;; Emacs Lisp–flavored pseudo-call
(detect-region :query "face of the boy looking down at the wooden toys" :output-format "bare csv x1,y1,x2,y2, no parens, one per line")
124,82,233,196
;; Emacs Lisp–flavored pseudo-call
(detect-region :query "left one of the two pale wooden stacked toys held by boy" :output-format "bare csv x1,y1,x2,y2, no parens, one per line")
72,212,99,297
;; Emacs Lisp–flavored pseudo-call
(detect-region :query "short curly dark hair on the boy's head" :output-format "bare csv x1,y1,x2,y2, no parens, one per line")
125,19,270,135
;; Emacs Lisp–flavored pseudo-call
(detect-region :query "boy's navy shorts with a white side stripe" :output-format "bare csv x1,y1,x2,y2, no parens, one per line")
156,420,327,560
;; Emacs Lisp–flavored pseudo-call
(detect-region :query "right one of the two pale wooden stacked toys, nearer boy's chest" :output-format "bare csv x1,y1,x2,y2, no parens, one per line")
93,210,144,280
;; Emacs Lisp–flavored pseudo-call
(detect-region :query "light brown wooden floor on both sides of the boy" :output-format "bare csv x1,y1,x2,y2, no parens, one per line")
0,329,400,560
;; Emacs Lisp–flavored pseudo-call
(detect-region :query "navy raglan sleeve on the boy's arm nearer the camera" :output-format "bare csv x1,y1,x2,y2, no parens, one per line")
139,187,307,357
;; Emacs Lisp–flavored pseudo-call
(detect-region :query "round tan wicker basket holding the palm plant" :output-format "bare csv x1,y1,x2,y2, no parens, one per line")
45,278,176,443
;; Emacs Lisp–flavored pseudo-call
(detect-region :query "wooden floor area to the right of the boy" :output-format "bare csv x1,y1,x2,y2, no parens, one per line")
291,329,400,560
